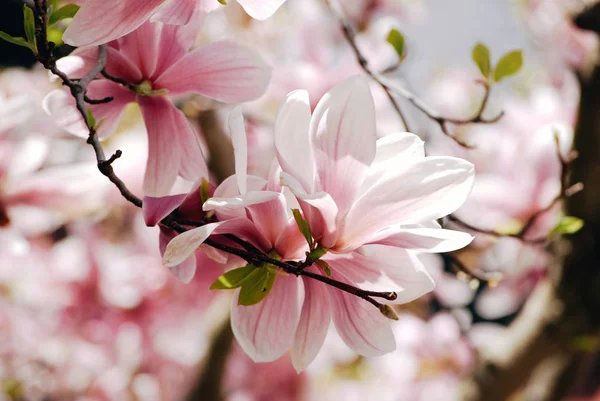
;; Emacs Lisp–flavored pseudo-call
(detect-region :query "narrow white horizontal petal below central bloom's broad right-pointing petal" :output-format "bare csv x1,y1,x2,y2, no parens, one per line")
371,228,473,253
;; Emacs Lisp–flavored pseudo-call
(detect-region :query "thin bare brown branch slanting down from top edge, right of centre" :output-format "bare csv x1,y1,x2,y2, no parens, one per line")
327,0,504,149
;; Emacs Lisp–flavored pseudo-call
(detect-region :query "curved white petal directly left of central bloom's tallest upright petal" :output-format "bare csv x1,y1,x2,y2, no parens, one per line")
274,90,315,192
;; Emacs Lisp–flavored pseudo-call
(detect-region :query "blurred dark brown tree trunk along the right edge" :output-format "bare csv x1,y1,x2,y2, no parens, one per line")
471,51,600,401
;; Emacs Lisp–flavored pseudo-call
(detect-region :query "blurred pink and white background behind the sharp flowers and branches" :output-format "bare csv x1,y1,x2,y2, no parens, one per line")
0,0,600,401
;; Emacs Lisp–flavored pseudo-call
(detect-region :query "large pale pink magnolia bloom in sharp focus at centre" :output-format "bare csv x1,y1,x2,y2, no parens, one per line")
163,77,473,371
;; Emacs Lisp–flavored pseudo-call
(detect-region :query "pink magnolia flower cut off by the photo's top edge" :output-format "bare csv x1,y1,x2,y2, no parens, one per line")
63,0,285,46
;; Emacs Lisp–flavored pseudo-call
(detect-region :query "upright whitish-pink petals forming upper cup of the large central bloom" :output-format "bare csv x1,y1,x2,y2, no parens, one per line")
275,77,473,252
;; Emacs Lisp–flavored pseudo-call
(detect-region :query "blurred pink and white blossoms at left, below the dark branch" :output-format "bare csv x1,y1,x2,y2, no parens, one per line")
0,69,226,400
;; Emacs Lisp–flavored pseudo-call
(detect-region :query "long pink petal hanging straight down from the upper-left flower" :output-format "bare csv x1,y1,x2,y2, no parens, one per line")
138,96,208,197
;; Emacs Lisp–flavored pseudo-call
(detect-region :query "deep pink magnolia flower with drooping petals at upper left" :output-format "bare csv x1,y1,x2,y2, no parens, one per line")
44,21,270,225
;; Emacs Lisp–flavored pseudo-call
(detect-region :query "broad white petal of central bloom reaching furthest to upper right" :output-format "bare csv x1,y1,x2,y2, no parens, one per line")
339,157,474,249
